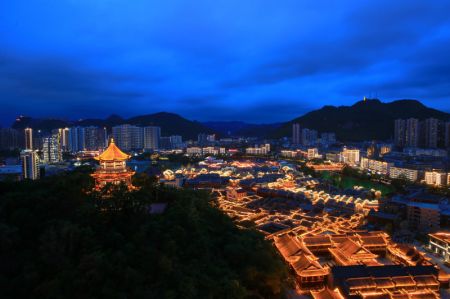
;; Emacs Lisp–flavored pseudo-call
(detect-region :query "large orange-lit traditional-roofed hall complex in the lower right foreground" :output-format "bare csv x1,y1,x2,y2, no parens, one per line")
273,231,440,299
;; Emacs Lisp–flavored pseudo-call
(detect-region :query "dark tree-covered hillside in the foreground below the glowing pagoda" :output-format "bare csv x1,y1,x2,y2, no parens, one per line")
0,172,286,299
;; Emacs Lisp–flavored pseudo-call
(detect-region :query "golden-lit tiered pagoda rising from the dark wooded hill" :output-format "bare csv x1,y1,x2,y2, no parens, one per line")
92,139,135,189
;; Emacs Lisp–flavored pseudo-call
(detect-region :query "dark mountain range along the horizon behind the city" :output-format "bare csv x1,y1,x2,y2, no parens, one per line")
12,99,450,141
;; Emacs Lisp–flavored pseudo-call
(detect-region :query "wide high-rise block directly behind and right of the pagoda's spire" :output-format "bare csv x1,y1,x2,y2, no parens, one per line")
112,124,144,151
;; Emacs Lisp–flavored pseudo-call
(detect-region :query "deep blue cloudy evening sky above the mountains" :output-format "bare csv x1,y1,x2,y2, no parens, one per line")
0,0,450,124
